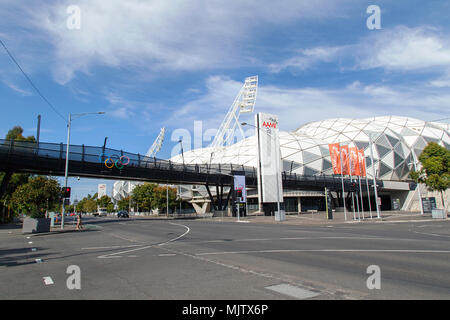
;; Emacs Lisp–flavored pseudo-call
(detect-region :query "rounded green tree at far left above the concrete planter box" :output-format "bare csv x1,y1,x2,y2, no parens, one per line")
11,176,61,218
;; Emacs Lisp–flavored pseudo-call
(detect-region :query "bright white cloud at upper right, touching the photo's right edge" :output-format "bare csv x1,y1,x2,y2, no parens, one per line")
269,26,450,76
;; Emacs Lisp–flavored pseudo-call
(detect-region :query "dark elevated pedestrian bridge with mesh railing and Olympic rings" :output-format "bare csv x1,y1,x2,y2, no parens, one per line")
0,139,382,191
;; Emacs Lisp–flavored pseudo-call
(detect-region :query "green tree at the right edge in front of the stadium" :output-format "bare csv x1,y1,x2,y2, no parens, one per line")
410,142,450,210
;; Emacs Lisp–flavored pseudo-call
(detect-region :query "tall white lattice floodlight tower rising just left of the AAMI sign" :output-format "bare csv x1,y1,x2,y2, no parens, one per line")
209,76,258,148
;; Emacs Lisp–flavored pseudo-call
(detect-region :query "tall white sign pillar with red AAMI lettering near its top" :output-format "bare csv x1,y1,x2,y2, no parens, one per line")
255,113,283,203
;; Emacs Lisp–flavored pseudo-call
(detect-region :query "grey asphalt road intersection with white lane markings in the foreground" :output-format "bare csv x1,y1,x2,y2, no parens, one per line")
0,217,450,300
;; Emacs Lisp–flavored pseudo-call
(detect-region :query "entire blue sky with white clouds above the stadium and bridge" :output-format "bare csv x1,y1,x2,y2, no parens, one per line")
0,0,450,198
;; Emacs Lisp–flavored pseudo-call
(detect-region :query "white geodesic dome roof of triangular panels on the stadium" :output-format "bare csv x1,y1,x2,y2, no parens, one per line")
171,116,450,180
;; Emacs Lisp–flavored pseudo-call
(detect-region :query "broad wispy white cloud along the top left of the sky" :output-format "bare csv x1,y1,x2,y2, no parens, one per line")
0,0,352,84
